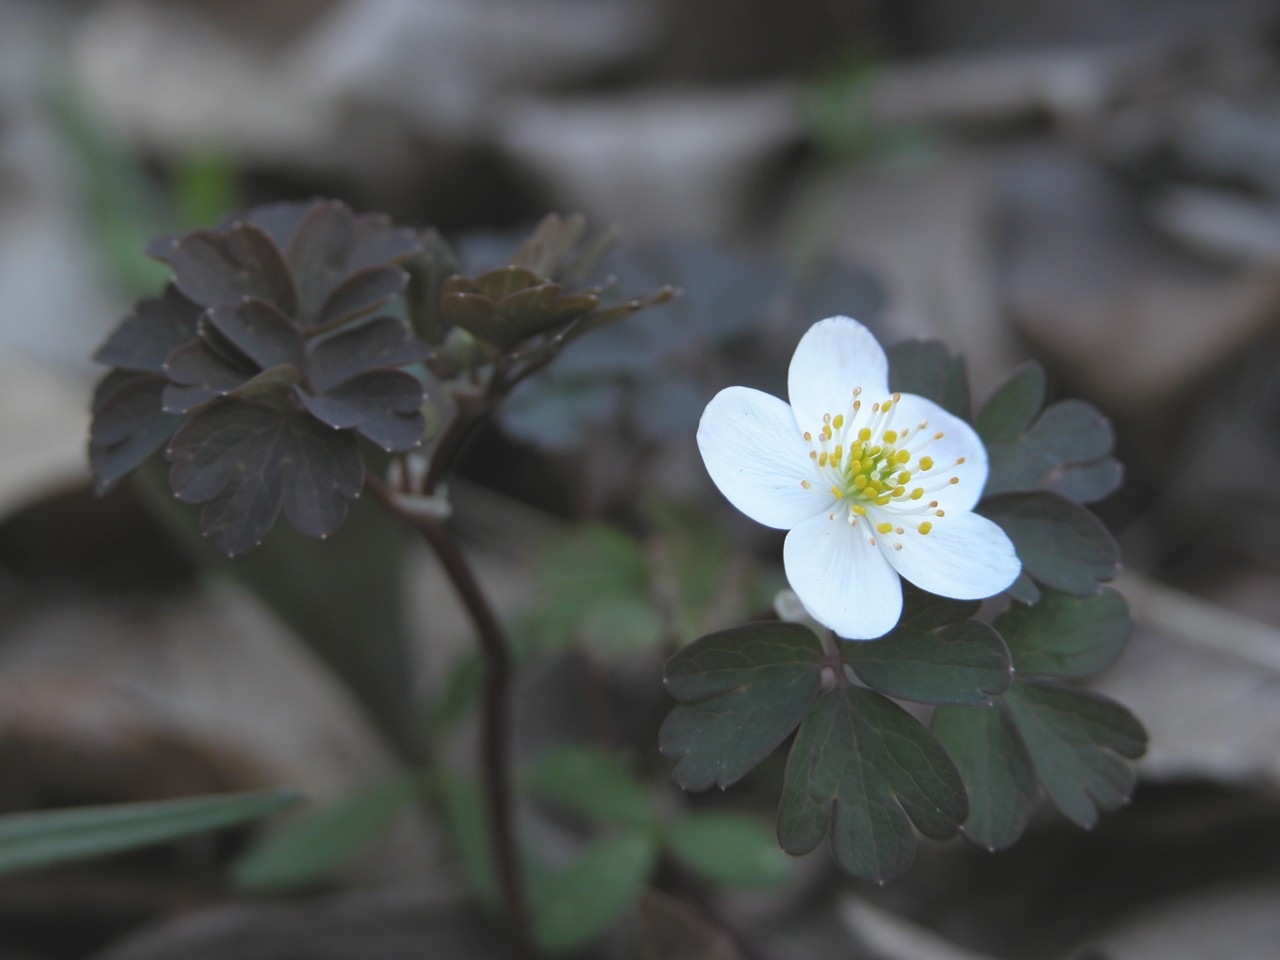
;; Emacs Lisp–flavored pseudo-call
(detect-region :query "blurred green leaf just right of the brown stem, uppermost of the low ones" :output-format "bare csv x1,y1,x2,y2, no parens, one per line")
527,746,654,824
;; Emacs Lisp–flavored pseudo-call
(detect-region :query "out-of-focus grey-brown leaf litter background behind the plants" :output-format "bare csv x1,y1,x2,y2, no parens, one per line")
0,0,1280,960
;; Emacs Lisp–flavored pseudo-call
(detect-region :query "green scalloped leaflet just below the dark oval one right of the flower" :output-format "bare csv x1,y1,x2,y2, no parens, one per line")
995,588,1133,677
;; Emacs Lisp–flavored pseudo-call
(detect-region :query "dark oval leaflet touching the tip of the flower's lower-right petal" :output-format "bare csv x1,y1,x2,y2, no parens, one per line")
978,492,1120,596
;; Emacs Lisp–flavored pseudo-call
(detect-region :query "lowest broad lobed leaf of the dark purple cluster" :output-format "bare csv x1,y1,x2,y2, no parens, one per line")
168,399,364,556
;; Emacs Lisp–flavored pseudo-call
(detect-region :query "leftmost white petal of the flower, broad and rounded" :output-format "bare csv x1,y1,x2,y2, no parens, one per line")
698,387,835,530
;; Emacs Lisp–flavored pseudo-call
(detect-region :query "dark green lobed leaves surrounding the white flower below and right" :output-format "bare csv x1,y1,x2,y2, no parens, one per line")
659,343,1146,882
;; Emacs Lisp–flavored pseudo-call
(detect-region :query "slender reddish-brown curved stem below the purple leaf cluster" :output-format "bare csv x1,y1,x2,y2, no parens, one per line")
365,475,535,955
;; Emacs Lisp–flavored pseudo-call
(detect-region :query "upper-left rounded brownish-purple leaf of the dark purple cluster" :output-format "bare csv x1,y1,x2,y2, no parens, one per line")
155,223,298,316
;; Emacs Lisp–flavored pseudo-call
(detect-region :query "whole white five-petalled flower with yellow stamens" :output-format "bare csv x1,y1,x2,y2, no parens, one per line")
698,316,1021,640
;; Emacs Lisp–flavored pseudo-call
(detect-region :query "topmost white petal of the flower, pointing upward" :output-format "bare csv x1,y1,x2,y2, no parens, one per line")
787,316,888,433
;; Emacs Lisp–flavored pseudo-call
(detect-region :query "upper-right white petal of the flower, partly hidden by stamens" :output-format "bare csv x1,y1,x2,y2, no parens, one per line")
893,393,988,511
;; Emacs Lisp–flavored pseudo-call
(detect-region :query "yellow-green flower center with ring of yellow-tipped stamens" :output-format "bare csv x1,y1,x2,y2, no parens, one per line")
801,387,964,550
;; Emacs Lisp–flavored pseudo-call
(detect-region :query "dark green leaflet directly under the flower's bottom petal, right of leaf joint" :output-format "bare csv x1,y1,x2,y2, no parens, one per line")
844,620,1010,704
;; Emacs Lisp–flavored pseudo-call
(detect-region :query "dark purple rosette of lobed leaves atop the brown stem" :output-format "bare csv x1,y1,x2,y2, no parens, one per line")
90,201,428,554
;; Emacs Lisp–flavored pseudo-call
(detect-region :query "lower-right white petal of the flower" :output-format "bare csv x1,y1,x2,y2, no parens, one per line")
884,511,1023,600
